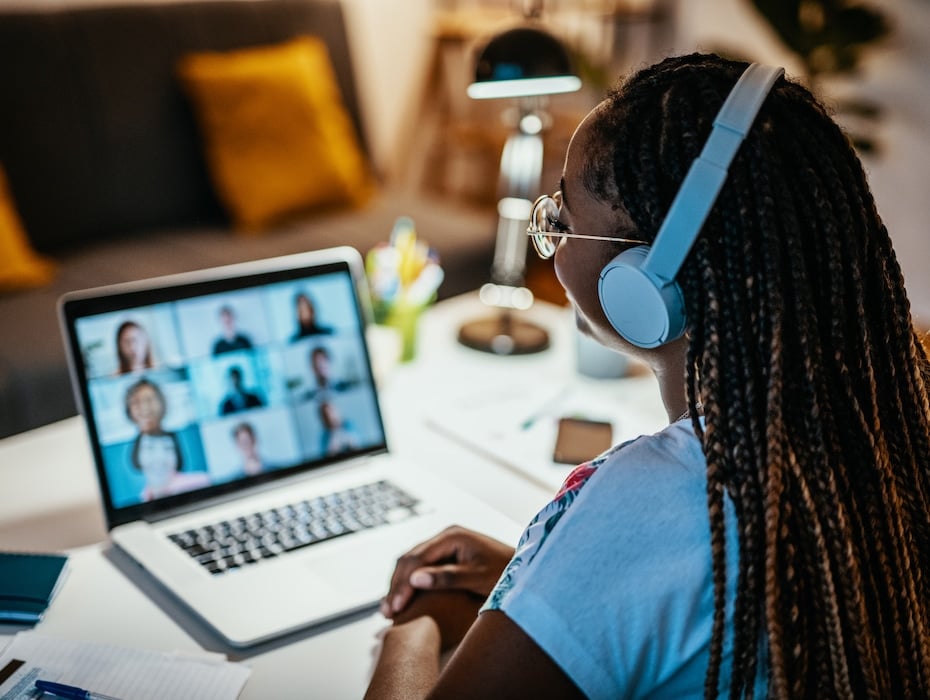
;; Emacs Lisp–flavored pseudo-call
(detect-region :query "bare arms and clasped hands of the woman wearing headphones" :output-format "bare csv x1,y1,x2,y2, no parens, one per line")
365,527,584,700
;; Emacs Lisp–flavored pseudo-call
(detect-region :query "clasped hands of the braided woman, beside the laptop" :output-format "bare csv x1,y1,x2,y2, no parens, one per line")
381,526,514,651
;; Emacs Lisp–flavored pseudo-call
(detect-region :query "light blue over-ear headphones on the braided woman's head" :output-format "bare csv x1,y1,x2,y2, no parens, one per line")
597,63,785,348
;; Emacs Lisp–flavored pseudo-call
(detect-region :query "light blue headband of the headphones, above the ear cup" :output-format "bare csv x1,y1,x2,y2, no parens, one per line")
642,63,785,282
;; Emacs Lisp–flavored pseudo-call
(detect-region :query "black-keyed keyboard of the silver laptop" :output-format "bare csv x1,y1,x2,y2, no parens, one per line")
169,480,418,574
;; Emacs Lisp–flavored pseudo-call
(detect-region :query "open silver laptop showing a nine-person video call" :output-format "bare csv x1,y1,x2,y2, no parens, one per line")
59,247,519,647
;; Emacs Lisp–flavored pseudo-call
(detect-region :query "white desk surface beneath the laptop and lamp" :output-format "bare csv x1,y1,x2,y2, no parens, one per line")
0,295,668,700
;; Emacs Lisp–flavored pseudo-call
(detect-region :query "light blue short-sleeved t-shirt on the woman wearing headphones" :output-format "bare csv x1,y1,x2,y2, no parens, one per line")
482,420,766,699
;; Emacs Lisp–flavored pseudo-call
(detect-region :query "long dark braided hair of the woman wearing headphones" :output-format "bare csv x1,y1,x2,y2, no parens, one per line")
584,54,930,698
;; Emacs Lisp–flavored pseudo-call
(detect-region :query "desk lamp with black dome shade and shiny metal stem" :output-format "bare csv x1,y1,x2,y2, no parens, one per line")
459,18,581,355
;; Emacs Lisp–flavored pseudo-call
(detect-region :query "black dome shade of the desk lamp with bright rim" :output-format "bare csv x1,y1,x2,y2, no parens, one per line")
468,27,581,100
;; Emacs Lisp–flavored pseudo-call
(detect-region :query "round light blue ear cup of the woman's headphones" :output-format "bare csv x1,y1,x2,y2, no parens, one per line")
597,245,686,348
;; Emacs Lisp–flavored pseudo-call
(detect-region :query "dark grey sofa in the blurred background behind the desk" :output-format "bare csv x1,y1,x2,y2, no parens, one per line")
0,0,495,437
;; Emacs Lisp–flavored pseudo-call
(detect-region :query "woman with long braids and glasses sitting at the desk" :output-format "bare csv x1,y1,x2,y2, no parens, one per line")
369,55,930,698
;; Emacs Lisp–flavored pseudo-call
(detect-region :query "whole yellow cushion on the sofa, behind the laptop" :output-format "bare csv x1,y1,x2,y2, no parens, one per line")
178,37,373,230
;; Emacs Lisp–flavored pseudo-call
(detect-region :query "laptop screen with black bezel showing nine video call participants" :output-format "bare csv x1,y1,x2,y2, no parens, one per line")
61,251,386,526
